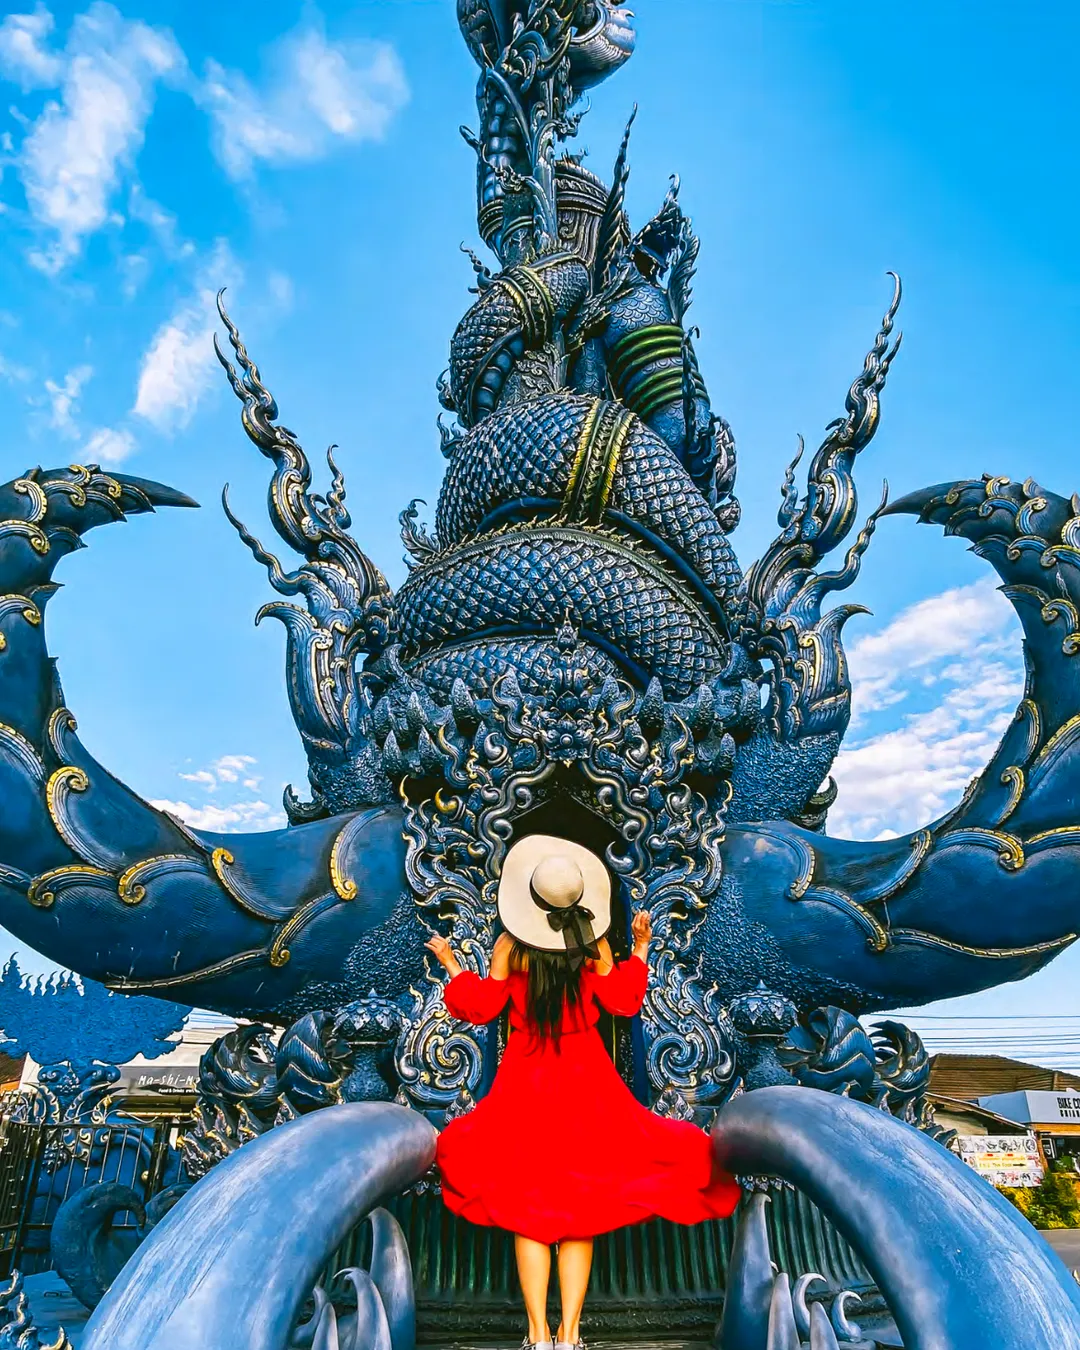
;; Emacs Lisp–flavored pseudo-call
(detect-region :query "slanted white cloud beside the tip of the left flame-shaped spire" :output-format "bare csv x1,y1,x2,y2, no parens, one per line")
132,244,238,432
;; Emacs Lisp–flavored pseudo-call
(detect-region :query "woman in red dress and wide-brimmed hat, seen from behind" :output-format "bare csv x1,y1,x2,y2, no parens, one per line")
427,834,738,1350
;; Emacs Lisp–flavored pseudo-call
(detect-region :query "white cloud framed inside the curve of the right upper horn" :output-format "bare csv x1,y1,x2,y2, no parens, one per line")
829,582,1023,838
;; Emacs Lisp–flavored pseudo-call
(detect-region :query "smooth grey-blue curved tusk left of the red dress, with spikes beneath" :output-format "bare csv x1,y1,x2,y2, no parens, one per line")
82,1103,435,1350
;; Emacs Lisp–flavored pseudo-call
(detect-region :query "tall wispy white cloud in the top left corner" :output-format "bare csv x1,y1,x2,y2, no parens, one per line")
0,0,186,274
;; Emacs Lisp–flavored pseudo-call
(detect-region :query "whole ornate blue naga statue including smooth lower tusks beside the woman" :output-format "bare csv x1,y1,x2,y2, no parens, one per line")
0,0,1080,1350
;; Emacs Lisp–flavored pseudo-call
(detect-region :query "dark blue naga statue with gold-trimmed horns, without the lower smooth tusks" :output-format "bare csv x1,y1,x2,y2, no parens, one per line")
0,0,1080,1161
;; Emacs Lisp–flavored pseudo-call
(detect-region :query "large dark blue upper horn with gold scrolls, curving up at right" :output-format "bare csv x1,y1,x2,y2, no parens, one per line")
725,478,1080,1010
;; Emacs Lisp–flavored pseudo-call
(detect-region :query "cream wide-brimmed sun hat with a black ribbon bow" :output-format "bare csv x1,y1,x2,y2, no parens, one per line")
498,834,612,963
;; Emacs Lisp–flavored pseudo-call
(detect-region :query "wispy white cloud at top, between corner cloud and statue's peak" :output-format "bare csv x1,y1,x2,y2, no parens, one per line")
200,26,409,180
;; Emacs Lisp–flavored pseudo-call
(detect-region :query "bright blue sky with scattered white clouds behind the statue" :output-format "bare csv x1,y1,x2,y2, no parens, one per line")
0,0,1080,1042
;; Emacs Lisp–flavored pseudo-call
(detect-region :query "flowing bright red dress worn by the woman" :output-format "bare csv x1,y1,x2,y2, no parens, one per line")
436,957,738,1243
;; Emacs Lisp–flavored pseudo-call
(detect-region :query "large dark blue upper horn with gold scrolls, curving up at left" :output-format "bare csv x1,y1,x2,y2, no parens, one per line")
0,453,419,1018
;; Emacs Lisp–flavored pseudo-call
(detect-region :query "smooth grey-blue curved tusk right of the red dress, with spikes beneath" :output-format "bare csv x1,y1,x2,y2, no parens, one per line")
713,1087,1080,1350
